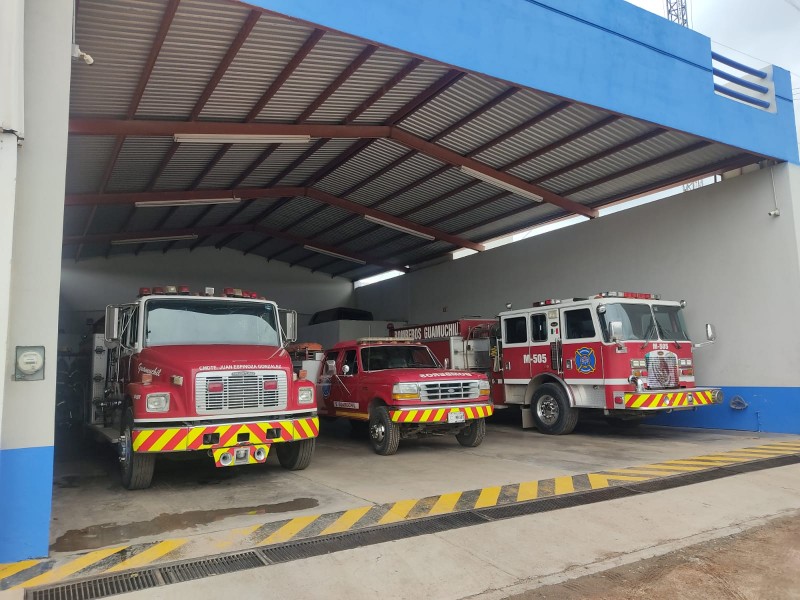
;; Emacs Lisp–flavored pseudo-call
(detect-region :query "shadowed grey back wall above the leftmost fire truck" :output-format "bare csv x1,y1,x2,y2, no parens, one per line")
61,248,353,333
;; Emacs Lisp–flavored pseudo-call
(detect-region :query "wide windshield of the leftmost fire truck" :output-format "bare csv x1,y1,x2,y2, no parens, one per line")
144,298,280,346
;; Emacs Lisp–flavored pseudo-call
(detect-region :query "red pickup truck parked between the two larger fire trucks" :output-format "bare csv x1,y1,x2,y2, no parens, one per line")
317,338,494,456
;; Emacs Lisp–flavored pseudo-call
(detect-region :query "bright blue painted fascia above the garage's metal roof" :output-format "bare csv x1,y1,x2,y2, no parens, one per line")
255,0,798,163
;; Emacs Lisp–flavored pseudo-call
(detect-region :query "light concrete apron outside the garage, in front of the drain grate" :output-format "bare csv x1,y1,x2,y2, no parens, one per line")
108,465,800,600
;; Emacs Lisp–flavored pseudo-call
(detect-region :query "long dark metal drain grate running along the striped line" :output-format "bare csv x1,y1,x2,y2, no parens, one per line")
25,454,800,600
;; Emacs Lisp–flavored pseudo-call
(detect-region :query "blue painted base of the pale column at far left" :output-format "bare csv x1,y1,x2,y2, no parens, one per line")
0,446,53,563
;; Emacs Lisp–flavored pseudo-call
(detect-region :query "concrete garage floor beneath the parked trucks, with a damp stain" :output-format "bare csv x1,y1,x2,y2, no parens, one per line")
51,411,800,555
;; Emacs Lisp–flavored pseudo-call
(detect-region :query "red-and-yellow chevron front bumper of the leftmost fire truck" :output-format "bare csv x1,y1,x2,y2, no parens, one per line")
133,417,319,454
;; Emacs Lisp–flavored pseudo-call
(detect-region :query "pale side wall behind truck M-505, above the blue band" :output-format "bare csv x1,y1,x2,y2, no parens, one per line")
356,164,800,387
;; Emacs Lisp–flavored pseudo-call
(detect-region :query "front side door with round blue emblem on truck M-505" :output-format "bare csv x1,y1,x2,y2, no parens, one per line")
561,306,603,385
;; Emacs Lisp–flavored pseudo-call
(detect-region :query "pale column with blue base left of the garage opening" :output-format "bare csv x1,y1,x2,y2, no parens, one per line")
0,0,72,563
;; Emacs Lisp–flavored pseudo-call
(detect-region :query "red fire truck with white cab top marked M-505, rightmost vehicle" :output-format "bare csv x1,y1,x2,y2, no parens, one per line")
390,292,722,435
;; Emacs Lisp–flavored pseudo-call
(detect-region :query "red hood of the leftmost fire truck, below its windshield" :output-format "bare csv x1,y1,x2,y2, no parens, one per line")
139,344,291,371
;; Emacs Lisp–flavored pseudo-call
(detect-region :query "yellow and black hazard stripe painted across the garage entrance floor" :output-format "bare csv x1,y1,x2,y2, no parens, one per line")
0,440,800,590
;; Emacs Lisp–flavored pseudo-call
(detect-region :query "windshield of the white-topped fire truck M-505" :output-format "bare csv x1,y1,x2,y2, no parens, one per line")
600,302,689,342
